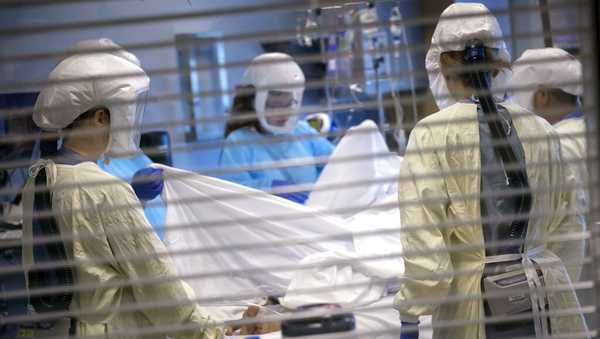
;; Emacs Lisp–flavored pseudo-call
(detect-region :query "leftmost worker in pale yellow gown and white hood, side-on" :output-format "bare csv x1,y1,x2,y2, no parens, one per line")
23,38,221,338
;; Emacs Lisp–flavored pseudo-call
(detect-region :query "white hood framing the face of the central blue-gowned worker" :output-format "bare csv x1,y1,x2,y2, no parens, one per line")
241,53,305,133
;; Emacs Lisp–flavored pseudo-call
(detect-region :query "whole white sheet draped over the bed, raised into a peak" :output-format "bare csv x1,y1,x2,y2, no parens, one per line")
162,122,412,338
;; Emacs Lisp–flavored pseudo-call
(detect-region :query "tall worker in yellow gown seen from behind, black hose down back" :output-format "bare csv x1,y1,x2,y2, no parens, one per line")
395,3,587,338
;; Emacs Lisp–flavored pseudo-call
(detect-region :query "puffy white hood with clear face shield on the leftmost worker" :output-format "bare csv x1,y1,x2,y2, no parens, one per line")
33,39,150,157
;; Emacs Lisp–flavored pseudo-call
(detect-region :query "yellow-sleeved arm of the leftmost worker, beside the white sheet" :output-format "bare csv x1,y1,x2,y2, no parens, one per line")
101,185,221,339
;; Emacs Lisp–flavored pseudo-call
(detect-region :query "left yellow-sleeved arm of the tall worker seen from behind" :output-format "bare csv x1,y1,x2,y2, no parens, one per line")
394,127,453,323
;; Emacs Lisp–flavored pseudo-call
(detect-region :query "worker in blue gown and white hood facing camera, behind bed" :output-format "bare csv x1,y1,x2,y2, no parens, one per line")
220,53,334,203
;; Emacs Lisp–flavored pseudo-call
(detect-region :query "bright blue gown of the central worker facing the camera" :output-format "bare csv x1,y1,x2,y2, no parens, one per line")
219,121,334,190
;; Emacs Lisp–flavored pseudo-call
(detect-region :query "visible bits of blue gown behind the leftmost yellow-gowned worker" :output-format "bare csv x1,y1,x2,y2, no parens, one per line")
98,154,166,239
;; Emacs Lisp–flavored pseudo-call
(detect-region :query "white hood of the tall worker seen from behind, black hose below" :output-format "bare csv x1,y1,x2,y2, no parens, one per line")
425,3,510,109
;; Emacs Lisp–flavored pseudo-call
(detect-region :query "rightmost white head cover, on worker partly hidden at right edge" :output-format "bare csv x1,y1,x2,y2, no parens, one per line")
510,48,583,112
